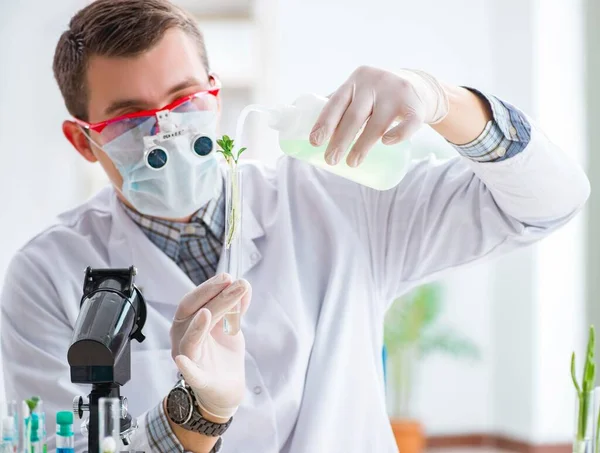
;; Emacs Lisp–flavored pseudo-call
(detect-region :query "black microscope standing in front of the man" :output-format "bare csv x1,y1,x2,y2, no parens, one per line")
67,266,146,453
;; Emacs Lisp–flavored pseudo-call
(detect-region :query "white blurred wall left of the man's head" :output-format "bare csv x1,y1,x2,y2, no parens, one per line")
0,0,90,282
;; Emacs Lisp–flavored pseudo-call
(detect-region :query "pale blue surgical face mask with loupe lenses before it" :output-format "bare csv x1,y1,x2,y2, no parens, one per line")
94,107,222,218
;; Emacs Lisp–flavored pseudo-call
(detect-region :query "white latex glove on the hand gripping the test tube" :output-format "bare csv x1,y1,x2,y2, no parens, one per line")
171,274,252,419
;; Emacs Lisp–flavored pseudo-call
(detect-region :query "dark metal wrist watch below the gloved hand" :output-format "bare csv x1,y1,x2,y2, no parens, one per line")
167,378,233,453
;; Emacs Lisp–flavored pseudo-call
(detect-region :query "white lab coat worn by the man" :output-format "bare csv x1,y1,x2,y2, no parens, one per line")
1,120,590,453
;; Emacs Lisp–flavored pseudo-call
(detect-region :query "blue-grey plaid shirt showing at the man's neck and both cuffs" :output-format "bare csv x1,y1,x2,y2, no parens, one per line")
134,90,531,453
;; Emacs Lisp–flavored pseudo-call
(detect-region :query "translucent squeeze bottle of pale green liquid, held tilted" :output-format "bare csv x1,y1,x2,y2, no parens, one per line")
264,94,431,190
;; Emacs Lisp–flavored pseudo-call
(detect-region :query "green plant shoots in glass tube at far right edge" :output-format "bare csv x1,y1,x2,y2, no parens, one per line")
571,326,600,451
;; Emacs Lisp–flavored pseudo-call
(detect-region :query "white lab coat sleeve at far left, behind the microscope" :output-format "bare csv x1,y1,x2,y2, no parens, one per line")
0,251,157,452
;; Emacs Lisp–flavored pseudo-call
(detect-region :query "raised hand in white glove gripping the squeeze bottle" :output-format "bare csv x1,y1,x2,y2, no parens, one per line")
310,66,449,167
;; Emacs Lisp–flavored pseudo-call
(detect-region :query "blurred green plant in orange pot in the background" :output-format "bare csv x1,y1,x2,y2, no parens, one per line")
384,284,479,453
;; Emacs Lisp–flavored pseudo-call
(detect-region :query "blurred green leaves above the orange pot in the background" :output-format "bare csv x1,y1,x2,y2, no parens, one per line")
384,284,480,417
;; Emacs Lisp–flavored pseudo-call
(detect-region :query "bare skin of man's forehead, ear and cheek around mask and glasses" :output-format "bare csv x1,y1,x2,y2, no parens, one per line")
63,29,214,206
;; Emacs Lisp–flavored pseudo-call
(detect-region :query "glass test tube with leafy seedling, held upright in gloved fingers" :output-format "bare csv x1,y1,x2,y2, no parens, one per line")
223,164,243,335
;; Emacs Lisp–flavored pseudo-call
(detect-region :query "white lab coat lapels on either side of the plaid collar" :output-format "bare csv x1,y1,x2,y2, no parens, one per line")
108,171,264,305
